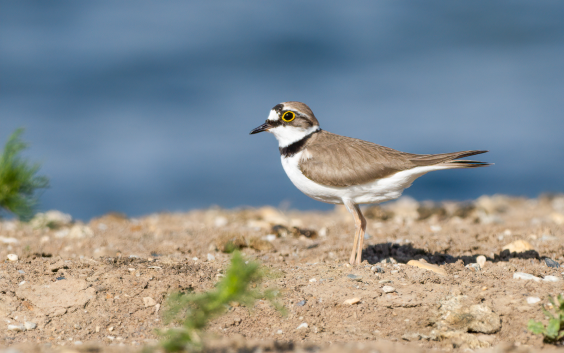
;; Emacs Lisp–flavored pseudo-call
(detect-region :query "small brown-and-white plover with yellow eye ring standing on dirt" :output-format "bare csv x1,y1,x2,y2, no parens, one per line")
250,101,491,265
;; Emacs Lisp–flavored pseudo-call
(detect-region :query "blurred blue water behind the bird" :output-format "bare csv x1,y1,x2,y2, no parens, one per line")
0,0,564,220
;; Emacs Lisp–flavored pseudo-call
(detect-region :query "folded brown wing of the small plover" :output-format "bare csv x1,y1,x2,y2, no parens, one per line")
299,131,486,187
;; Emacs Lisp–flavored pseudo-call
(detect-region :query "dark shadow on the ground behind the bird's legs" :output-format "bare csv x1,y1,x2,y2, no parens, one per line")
362,243,544,265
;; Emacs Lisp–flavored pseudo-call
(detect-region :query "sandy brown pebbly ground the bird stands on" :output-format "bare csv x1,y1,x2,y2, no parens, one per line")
0,196,564,352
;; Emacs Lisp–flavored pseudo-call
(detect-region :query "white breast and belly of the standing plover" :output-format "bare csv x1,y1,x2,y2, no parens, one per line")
281,150,448,204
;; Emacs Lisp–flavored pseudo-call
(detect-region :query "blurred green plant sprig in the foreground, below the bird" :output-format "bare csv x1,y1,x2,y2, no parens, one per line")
159,251,282,352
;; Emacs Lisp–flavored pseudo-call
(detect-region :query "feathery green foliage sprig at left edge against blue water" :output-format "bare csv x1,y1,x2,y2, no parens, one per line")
0,128,49,221
